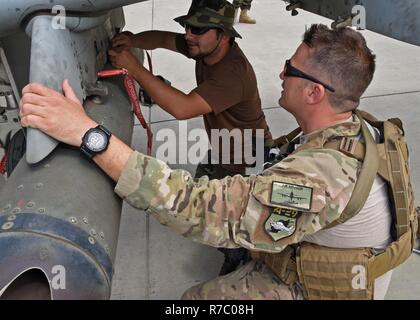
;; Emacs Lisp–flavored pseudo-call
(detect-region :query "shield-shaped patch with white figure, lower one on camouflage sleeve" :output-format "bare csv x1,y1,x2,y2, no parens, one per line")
264,208,298,241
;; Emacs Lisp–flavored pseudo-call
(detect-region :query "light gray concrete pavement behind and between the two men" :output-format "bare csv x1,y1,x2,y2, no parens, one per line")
112,0,420,299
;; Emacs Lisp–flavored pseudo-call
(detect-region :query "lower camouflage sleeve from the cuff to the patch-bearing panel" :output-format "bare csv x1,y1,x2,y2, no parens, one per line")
115,152,254,248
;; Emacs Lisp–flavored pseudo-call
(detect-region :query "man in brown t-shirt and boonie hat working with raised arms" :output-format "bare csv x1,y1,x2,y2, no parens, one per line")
110,0,271,274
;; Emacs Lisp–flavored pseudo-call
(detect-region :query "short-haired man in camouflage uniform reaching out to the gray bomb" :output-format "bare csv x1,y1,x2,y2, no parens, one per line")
21,25,391,299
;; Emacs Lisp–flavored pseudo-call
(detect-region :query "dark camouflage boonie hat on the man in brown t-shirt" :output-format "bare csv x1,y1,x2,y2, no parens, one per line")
174,0,242,38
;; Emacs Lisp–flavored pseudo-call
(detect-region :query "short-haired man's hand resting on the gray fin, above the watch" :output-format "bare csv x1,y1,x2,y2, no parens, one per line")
19,80,97,146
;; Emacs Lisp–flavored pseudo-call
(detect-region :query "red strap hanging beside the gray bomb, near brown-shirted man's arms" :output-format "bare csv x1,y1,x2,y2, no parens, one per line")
98,68,153,156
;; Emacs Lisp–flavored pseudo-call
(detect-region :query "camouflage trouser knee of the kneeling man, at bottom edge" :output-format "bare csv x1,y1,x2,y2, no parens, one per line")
181,260,303,300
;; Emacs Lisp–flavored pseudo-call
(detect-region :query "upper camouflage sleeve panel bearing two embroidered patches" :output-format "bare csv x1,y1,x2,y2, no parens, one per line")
236,149,359,253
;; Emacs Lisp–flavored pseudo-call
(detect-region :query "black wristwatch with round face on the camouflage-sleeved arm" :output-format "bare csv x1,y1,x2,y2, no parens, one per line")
80,125,112,159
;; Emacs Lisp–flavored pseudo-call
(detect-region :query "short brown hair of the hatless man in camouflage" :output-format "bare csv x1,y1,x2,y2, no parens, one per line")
303,24,375,112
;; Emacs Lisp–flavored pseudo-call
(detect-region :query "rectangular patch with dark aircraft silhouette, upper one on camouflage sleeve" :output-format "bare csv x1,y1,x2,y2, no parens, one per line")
271,181,313,211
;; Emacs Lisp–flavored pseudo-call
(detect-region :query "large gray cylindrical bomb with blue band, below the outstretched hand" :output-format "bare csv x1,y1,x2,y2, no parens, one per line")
0,80,134,299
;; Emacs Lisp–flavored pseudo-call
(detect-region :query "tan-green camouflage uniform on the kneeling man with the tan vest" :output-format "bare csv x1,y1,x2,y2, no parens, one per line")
115,117,360,299
